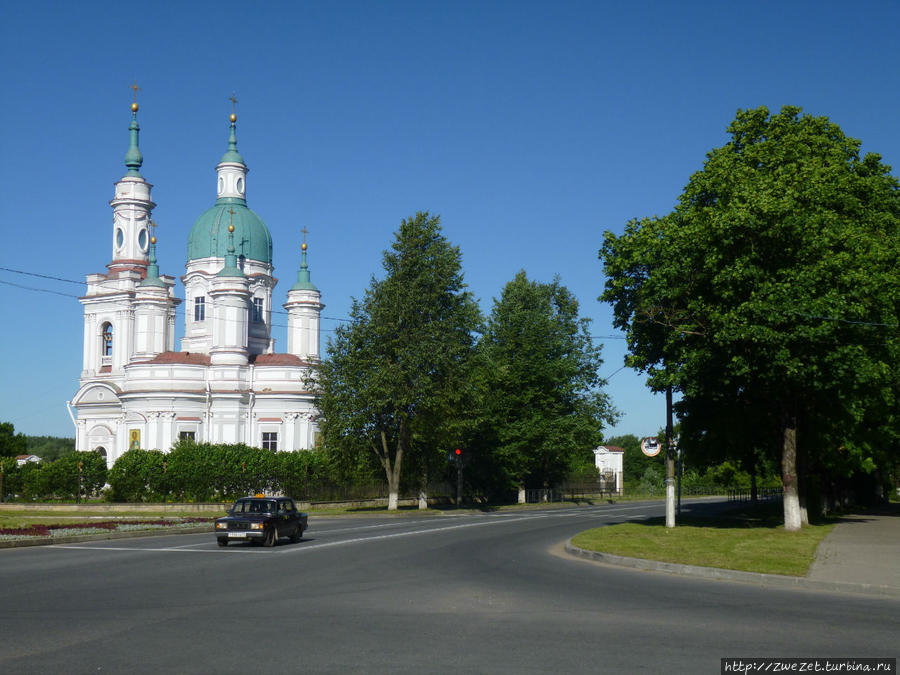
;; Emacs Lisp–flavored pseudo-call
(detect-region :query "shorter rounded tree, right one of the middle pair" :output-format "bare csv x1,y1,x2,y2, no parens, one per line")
480,272,615,501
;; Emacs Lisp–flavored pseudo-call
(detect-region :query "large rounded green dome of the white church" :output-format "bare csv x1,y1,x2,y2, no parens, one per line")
188,197,272,265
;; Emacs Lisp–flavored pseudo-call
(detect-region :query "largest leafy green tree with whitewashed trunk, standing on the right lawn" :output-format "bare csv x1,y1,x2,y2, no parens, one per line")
600,107,900,530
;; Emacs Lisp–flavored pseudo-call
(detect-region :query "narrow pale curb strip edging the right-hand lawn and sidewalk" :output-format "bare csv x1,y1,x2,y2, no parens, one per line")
566,539,900,598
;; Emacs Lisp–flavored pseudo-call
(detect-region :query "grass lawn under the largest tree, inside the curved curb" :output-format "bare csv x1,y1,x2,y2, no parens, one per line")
572,506,835,576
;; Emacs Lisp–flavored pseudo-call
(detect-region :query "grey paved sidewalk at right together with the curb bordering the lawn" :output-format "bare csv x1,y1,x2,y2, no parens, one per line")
565,504,900,598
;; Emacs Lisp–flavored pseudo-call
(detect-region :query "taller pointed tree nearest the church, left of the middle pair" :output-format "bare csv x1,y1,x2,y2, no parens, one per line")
317,213,481,510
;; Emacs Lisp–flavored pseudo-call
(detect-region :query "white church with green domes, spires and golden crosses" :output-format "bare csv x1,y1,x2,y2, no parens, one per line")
69,103,324,466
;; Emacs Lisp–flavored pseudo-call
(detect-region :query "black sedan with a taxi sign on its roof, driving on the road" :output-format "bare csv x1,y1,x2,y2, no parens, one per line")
216,495,307,546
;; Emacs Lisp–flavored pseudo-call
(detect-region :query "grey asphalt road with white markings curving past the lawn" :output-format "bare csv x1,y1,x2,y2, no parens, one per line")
0,503,900,673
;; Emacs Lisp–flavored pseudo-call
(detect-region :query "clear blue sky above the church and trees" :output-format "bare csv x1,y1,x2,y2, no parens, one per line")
0,0,900,437
